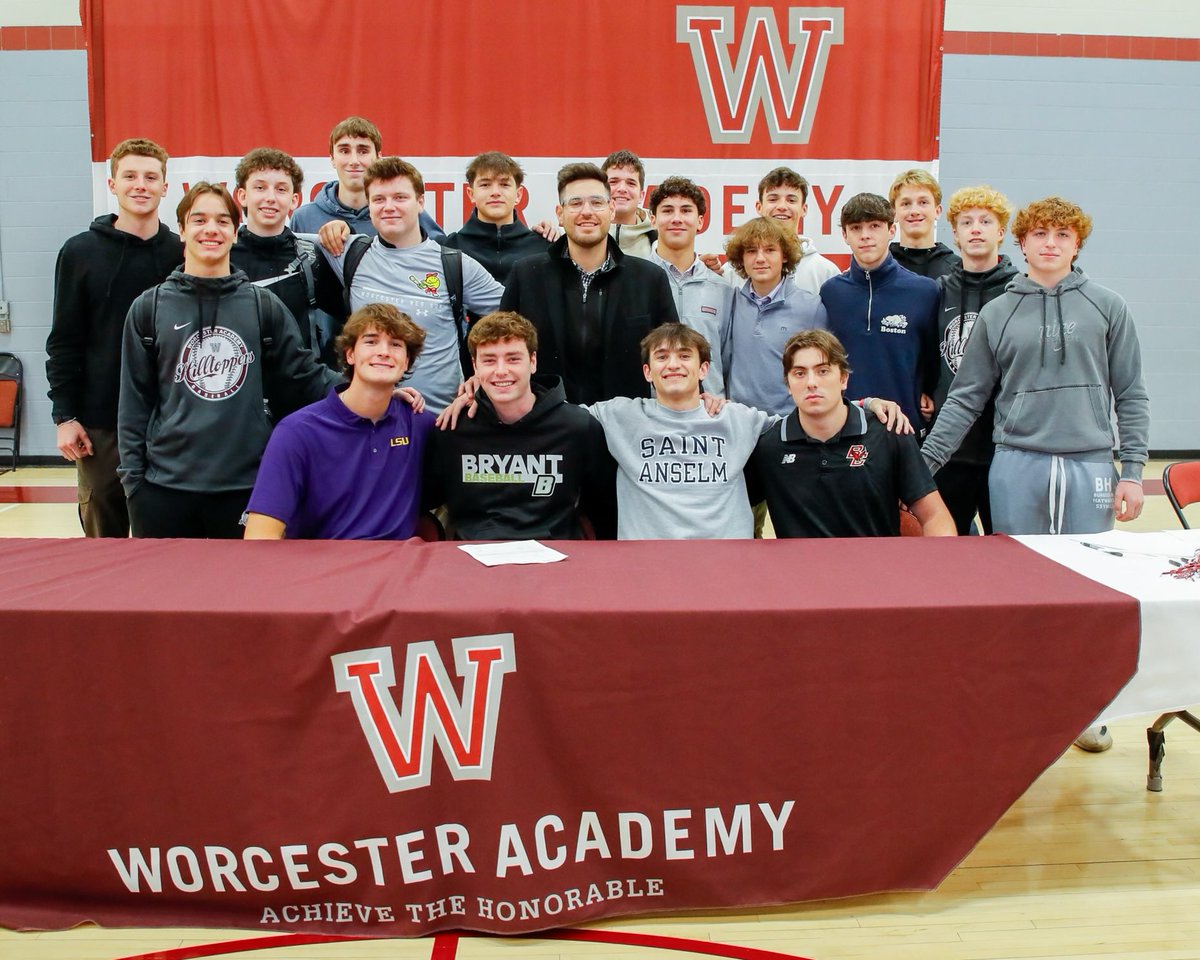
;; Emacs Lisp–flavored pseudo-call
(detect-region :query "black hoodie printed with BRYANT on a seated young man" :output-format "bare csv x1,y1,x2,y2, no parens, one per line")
424,374,617,540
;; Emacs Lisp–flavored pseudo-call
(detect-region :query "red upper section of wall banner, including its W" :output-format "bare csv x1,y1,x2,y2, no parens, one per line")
83,0,943,162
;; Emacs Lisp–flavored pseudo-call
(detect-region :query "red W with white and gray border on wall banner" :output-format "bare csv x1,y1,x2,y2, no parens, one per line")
676,7,842,143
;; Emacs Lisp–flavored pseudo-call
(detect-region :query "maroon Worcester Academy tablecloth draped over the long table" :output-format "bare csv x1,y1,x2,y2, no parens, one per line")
0,538,1138,936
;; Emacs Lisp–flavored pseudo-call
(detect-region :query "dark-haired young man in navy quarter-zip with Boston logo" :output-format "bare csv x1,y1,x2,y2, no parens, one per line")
821,193,938,431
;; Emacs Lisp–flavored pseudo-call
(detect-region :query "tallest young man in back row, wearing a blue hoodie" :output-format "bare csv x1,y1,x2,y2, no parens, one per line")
292,116,444,238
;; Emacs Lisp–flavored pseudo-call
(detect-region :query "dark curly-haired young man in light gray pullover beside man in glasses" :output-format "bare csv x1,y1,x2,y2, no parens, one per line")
650,176,733,397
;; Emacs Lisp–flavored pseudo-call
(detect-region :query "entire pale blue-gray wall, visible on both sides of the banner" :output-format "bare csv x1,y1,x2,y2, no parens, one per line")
0,50,1200,456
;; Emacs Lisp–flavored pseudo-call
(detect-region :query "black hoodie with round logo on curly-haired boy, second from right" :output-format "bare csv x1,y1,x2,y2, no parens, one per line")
934,254,1018,463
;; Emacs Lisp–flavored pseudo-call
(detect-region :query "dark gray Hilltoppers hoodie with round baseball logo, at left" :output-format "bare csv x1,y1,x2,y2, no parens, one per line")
118,270,342,497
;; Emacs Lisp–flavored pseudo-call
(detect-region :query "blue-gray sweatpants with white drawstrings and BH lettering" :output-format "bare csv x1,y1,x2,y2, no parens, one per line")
988,449,1118,534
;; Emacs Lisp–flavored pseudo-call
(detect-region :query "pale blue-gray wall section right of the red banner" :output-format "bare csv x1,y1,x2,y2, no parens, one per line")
940,55,1200,451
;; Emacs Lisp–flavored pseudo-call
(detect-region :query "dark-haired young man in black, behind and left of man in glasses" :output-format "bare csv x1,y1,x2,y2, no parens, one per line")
444,150,550,283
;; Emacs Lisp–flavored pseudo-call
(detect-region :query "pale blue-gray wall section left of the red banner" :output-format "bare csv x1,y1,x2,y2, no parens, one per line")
0,50,91,464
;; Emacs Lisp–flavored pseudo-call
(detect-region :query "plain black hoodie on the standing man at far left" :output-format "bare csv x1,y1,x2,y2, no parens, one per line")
46,214,184,430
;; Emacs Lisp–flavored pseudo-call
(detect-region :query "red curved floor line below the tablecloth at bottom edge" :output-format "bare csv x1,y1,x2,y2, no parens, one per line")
118,929,810,960
